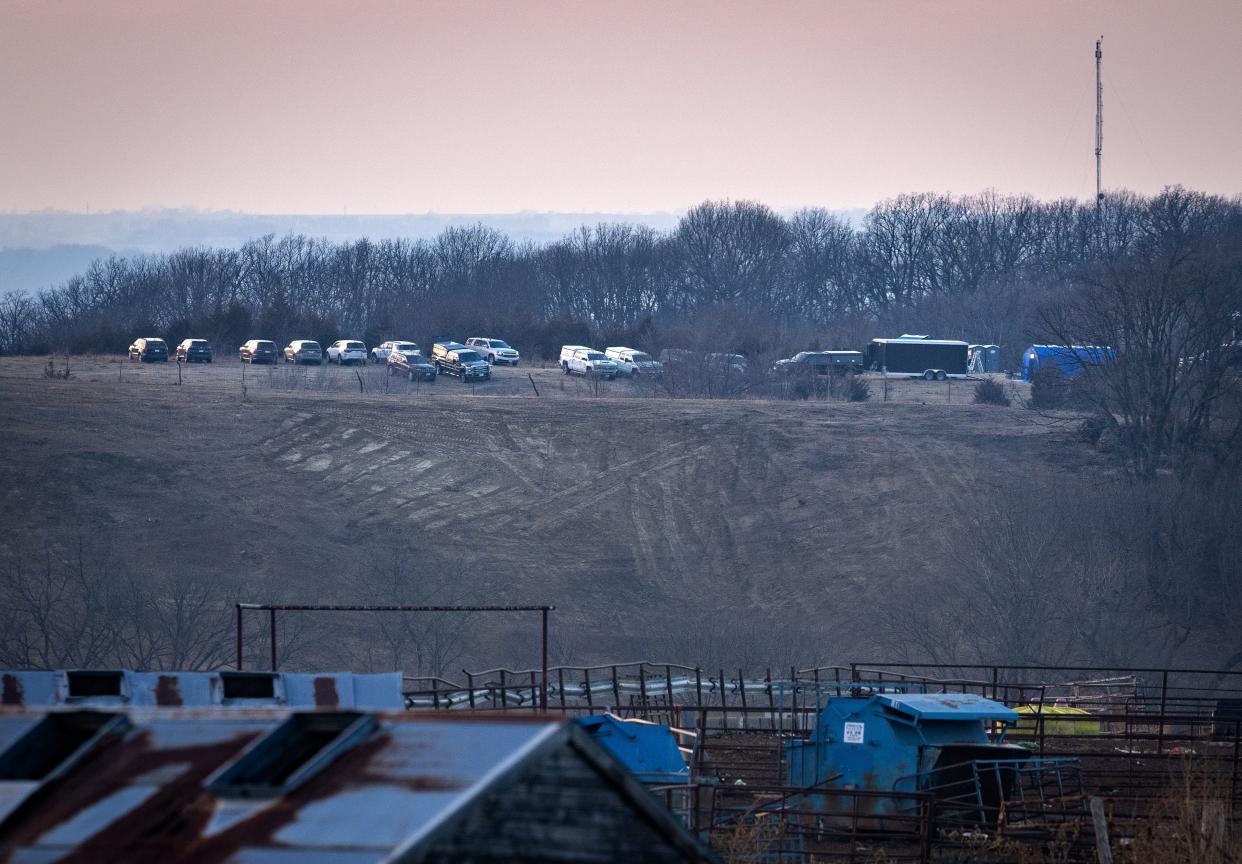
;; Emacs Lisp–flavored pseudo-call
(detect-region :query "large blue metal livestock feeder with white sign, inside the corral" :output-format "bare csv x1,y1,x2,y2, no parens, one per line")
785,693,1035,824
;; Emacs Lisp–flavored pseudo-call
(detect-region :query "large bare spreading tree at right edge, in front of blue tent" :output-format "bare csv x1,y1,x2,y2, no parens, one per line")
1041,189,1242,479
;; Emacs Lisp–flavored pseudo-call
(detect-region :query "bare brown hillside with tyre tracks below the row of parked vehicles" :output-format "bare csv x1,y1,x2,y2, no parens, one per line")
0,359,1104,668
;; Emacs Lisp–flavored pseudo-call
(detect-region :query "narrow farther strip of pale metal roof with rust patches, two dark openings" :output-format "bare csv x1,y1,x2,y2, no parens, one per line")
0,669,405,710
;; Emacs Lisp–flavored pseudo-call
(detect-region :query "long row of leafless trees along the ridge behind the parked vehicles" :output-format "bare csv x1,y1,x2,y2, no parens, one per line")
0,189,1242,365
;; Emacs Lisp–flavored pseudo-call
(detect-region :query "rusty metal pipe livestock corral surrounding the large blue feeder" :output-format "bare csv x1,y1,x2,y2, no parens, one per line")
406,662,1242,863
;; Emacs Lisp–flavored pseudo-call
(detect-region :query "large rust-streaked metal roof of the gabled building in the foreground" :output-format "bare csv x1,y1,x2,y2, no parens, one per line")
0,709,714,863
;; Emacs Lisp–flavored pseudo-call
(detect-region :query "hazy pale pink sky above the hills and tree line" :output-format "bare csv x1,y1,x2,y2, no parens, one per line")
0,0,1242,214
